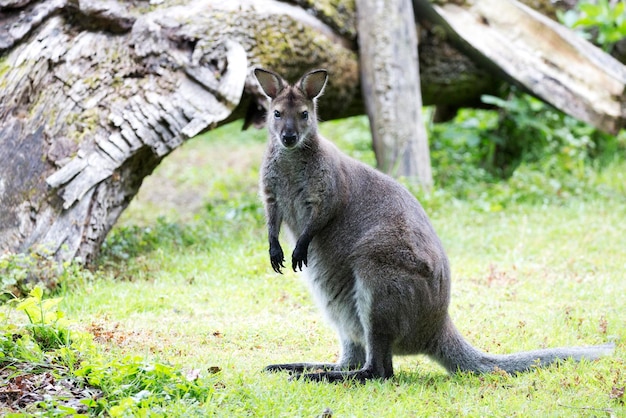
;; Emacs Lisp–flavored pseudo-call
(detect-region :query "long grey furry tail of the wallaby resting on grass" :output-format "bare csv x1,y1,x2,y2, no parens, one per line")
430,318,614,374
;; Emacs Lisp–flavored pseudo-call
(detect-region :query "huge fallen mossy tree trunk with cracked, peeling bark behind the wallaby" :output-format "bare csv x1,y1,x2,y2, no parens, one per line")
0,0,624,262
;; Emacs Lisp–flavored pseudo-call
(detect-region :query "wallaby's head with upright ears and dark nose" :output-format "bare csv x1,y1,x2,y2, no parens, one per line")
254,68,328,148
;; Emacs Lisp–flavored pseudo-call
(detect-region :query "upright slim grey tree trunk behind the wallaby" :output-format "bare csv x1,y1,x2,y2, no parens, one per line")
357,0,433,190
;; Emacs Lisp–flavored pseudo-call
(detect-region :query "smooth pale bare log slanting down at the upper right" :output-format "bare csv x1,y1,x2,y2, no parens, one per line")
413,0,626,134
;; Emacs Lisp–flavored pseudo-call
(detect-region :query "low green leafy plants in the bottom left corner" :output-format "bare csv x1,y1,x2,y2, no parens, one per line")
0,286,215,417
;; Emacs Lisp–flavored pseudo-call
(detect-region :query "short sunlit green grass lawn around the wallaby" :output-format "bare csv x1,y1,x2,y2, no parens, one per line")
3,118,626,417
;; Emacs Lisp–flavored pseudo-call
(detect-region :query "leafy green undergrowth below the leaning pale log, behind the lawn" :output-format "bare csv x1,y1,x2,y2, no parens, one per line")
420,90,626,211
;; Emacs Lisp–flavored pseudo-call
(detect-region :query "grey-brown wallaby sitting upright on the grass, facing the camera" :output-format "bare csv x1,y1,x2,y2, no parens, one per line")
254,69,612,381
